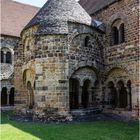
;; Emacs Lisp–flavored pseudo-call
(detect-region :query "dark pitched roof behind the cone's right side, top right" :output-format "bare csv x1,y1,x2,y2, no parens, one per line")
79,0,119,15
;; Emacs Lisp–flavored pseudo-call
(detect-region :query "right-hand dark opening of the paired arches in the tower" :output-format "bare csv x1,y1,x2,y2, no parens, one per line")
82,80,90,108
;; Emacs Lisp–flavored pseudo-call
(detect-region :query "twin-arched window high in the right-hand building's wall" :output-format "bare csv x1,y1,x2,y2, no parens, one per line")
111,19,125,45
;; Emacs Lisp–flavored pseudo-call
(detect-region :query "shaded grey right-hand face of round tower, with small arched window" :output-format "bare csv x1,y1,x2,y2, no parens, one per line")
68,23,104,107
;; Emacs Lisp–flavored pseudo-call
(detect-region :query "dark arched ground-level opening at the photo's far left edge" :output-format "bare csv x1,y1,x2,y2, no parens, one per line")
1,87,7,106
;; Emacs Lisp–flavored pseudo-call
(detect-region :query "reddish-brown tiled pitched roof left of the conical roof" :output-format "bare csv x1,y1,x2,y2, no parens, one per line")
0,0,40,37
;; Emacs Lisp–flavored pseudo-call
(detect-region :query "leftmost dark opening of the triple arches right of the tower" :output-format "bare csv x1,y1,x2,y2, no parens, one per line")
108,81,118,108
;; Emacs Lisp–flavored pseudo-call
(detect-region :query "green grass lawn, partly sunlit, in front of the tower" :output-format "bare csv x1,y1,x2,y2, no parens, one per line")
1,112,139,140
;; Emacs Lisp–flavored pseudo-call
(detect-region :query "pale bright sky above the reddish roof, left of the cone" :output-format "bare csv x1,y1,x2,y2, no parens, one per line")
14,0,78,7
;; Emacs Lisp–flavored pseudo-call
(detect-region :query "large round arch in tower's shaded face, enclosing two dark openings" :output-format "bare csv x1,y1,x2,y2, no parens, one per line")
69,68,96,109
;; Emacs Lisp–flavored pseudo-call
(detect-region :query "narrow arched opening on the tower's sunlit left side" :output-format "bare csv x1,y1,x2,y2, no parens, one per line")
27,81,34,109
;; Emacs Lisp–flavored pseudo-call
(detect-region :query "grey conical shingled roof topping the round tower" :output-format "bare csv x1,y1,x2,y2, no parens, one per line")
25,0,92,34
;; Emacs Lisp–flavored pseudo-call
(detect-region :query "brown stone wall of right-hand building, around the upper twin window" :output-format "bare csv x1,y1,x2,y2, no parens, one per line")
92,0,139,117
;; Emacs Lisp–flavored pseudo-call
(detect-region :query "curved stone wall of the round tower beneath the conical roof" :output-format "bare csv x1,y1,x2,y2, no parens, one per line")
15,23,103,115
